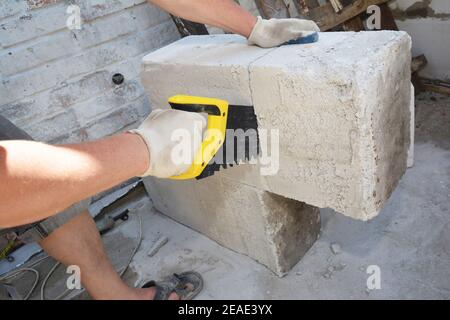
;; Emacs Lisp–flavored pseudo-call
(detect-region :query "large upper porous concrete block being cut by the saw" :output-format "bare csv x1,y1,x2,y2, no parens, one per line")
141,31,411,220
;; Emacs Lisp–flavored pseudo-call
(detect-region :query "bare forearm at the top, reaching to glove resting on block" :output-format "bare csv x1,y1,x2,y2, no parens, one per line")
148,0,256,38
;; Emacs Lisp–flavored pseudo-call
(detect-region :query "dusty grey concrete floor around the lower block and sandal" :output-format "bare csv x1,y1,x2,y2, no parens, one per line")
7,93,450,299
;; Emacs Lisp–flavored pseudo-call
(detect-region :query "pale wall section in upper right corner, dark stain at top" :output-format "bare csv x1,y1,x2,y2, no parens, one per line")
390,0,450,80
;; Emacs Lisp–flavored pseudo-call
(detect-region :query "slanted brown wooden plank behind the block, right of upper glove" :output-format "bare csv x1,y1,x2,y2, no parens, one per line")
309,0,392,31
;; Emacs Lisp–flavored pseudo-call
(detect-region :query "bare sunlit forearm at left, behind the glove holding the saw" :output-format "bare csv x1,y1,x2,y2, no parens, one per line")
0,133,149,228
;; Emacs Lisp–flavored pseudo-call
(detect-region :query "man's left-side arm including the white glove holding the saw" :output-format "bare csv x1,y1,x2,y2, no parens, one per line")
0,110,206,228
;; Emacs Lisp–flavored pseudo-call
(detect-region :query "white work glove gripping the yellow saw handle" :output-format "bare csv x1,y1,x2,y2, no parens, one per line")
130,109,207,178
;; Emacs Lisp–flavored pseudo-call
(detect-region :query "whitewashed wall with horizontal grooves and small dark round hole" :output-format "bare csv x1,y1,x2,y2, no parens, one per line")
0,0,179,143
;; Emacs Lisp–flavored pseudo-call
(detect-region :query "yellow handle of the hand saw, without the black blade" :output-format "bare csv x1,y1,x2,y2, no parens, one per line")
169,95,228,180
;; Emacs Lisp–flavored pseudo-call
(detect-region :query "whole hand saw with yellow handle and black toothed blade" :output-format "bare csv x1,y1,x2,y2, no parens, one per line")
169,95,259,180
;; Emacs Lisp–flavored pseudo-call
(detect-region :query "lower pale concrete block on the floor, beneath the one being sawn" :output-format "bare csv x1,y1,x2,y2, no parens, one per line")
144,175,320,276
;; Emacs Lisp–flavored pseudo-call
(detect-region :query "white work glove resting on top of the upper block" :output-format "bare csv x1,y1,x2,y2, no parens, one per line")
248,17,320,48
